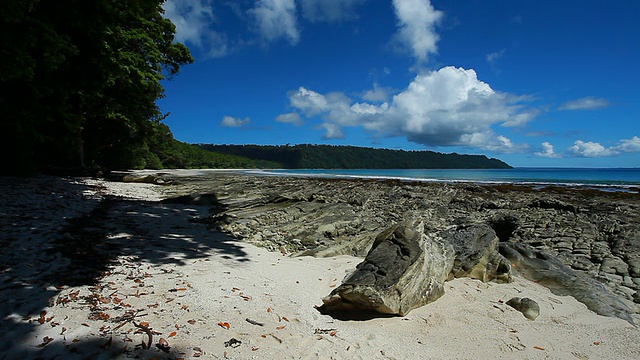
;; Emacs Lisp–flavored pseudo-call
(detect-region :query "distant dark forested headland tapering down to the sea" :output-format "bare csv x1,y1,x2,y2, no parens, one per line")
200,144,510,169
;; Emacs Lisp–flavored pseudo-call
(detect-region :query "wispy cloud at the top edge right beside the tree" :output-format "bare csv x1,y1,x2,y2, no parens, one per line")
163,0,229,57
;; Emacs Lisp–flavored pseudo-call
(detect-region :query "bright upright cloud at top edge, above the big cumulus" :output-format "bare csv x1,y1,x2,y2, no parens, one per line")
393,0,443,62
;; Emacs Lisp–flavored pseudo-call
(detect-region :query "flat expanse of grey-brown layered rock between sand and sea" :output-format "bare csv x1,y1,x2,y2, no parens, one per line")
145,173,640,320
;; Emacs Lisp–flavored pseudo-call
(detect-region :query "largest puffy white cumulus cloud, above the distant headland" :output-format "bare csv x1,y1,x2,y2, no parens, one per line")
282,67,533,153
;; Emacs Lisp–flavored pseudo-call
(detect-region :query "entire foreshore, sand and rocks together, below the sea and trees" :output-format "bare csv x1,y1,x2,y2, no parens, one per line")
0,170,640,360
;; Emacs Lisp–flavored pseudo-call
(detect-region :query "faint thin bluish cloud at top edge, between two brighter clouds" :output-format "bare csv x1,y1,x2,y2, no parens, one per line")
298,0,366,22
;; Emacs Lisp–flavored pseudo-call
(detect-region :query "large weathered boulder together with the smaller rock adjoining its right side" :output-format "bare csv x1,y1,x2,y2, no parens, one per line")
320,219,510,316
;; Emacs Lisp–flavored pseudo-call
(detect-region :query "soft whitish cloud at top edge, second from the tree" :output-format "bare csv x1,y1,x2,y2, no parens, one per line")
249,0,300,45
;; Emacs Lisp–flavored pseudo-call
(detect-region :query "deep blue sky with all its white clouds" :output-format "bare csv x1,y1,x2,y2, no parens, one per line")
159,0,640,167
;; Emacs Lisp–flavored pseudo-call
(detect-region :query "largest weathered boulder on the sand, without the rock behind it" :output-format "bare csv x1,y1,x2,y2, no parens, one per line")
320,220,454,316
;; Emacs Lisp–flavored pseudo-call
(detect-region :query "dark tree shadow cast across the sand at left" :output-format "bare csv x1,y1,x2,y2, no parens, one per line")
0,177,249,359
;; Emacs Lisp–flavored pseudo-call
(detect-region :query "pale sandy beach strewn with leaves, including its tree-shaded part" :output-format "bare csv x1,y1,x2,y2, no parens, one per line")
0,176,640,359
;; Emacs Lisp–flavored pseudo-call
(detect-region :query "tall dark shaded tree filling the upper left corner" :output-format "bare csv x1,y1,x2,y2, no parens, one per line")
0,0,193,174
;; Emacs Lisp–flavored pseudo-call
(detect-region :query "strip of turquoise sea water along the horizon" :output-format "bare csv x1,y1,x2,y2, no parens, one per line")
248,167,640,187
